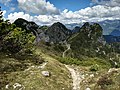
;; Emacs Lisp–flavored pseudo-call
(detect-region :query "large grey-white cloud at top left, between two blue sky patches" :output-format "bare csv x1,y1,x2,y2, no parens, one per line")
17,0,59,14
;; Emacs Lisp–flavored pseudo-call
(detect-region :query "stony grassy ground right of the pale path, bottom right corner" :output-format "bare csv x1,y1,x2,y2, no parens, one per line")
79,67,120,90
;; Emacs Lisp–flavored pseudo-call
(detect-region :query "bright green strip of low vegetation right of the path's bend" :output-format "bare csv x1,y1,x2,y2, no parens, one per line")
58,57,111,71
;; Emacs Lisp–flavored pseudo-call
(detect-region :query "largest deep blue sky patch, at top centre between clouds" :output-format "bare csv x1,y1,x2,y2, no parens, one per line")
47,0,91,11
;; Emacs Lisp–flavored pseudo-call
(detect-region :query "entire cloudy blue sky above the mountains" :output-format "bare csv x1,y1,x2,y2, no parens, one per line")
0,0,120,25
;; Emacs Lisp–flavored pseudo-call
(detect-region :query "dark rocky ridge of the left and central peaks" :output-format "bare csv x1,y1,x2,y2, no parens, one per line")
14,18,71,43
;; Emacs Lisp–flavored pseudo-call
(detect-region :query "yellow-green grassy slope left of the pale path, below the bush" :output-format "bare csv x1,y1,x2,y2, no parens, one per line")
0,50,72,90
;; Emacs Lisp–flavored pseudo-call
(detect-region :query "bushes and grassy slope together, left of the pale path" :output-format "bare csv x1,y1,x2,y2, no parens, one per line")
0,8,72,90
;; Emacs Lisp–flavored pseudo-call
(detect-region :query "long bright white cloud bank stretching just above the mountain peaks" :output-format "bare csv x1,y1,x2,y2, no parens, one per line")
8,4,120,25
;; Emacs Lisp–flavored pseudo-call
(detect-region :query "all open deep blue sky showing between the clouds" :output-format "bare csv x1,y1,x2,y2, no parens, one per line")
0,0,91,18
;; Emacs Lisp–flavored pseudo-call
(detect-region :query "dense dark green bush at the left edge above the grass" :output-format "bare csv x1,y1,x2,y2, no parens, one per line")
0,8,35,54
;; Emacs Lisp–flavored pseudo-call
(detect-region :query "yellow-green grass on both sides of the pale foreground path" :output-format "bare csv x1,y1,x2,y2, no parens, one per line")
0,46,120,90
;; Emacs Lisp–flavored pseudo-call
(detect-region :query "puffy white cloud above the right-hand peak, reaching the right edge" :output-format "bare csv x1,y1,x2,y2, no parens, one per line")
62,5,120,23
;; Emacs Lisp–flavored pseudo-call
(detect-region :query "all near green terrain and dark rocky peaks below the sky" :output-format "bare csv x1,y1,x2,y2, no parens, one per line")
0,5,120,90
